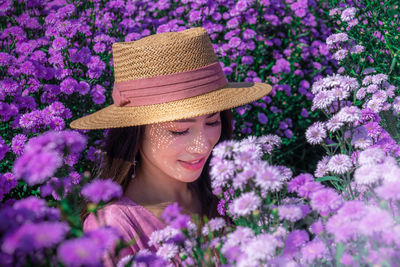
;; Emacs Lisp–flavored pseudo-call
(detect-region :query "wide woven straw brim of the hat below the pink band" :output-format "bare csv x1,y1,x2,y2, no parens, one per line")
70,82,272,130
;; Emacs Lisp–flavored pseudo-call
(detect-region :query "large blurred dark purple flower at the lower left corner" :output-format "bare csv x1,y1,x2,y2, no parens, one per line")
1,222,69,254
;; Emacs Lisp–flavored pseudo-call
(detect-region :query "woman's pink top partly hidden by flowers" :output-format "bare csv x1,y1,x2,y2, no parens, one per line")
83,196,166,266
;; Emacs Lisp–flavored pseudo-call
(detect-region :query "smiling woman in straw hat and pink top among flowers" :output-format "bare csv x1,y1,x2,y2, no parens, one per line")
71,28,271,265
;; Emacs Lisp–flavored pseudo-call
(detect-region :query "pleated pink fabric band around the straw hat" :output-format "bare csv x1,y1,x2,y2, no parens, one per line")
112,62,228,107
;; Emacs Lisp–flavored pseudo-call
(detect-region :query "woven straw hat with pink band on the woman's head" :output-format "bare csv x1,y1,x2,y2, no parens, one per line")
70,28,272,129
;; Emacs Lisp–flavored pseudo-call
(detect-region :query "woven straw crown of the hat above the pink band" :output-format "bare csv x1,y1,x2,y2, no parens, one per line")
112,28,217,83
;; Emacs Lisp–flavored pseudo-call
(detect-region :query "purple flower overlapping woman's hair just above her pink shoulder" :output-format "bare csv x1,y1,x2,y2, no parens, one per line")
82,179,122,203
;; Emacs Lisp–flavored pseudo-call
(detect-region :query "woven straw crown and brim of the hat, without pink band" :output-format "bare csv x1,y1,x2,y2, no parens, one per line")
70,28,272,129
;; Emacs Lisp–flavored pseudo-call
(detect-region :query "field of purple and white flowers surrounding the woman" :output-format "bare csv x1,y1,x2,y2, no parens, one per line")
0,0,400,266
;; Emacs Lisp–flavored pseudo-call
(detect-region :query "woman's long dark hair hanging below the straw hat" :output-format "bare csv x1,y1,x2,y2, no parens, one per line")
85,110,233,218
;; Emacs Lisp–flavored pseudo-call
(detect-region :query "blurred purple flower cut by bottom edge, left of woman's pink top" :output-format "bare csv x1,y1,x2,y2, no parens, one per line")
57,237,102,267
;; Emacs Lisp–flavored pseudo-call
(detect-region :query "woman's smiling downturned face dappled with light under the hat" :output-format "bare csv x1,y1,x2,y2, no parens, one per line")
140,112,221,183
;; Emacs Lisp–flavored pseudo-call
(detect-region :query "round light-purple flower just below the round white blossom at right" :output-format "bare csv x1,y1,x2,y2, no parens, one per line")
310,188,343,216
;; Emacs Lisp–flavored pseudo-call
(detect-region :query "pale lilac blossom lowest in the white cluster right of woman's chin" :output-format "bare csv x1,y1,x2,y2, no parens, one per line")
229,192,261,216
